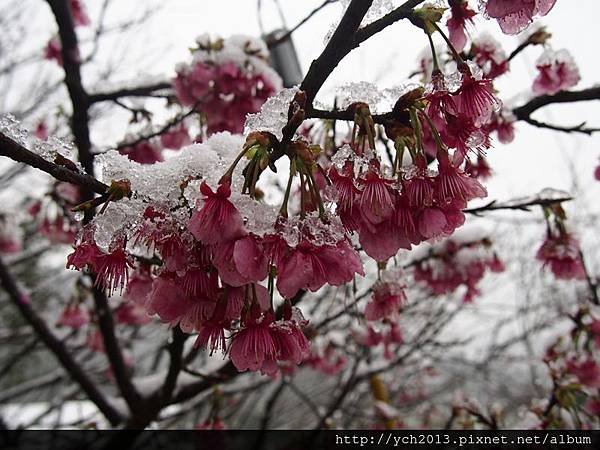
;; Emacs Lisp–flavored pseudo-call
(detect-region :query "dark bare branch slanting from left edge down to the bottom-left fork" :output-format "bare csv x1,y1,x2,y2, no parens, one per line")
0,258,123,425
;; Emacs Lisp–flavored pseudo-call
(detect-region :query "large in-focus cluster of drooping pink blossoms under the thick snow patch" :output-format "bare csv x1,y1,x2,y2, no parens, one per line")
68,171,363,374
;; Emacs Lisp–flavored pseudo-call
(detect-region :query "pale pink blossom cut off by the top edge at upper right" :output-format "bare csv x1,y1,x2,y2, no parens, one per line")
480,0,556,34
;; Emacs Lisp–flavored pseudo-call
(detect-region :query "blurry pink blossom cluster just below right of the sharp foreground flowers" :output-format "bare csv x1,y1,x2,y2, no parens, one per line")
414,239,504,302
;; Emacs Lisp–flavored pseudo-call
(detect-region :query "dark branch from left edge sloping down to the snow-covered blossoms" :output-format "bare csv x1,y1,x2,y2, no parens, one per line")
0,133,108,195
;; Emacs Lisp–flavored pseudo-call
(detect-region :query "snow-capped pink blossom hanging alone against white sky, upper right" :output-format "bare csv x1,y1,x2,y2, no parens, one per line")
533,49,581,95
